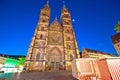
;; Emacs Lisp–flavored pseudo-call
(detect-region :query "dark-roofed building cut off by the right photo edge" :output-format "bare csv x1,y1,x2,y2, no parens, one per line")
112,33,120,56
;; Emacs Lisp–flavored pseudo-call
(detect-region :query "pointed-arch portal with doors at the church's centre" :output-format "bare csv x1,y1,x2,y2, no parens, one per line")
49,47,62,70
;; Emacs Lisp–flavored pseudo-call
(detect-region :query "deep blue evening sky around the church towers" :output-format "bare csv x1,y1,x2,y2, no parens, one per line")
0,0,120,55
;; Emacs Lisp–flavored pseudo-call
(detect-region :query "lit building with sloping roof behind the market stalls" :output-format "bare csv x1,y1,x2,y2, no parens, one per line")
81,48,115,59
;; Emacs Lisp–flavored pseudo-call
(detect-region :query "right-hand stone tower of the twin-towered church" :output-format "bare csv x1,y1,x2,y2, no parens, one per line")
61,5,80,70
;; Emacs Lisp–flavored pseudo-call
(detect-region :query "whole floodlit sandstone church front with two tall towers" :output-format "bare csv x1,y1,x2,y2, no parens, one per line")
24,3,80,71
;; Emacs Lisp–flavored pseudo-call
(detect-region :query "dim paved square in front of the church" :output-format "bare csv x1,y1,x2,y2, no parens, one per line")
0,71,77,80
